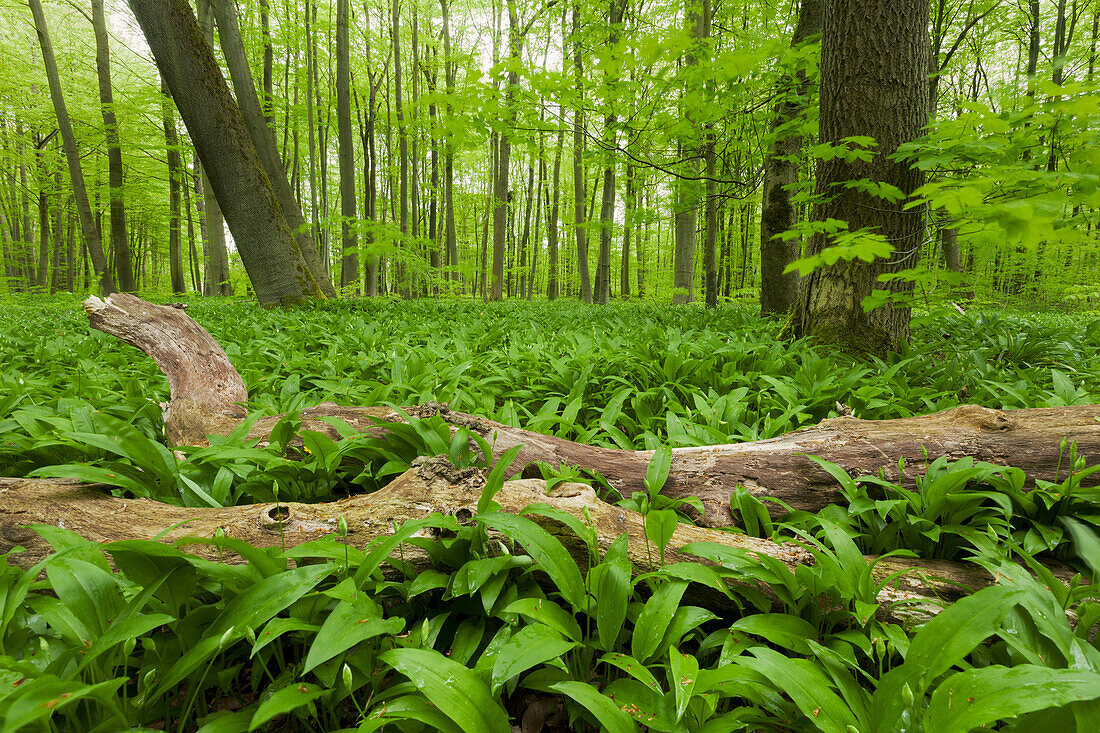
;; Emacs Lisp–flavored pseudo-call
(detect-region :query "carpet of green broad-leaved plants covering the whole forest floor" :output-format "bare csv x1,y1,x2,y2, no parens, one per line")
0,298,1100,733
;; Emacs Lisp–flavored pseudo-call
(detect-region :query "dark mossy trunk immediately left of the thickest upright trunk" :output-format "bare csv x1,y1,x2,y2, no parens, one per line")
760,0,823,316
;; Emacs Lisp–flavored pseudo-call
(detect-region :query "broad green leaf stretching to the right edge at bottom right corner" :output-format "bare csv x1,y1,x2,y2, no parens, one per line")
924,665,1100,731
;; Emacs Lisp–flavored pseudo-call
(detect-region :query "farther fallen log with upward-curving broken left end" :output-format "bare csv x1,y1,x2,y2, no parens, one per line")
85,294,1100,527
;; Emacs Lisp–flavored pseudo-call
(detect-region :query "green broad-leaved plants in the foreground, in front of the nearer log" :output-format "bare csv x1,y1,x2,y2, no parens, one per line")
0,457,1100,733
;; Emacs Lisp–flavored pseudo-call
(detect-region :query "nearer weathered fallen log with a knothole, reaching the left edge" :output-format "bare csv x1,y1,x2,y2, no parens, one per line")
0,458,1042,625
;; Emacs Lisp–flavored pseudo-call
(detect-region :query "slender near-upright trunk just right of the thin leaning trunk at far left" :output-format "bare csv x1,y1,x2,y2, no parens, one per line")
91,0,134,293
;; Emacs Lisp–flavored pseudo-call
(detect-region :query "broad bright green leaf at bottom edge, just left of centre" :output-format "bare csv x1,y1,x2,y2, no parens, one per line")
378,648,512,733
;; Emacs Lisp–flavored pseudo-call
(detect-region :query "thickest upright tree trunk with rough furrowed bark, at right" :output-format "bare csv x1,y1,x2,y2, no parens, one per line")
791,0,930,353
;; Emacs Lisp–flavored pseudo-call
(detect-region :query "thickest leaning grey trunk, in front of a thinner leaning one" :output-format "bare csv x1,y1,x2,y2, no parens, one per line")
130,0,322,305
